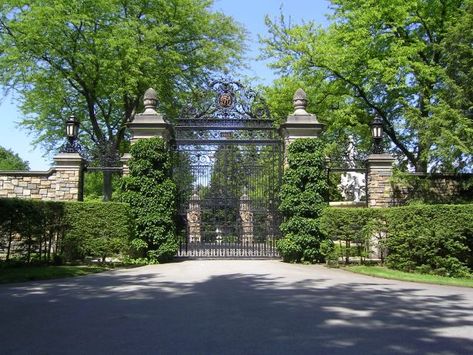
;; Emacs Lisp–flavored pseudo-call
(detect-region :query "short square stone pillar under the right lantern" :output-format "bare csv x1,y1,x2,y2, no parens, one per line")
367,153,394,207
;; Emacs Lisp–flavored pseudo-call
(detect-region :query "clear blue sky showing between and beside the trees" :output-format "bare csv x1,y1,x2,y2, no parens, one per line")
0,0,329,170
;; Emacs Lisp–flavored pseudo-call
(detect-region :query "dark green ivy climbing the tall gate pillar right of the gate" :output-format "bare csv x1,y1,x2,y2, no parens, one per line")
278,139,327,263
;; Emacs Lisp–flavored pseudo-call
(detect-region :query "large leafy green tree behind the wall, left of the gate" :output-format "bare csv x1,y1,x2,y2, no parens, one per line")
0,0,244,165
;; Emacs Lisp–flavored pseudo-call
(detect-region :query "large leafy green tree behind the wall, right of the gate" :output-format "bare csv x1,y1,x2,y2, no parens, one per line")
263,0,473,171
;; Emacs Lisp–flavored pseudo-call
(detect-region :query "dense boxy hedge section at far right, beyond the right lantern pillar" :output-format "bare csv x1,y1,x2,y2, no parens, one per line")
386,205,473,276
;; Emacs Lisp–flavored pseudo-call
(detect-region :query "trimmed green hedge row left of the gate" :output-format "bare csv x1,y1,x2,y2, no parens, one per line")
0,199,133,263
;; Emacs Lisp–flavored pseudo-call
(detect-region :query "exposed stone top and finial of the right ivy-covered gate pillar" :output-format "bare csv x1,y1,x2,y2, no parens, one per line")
279,89,325,165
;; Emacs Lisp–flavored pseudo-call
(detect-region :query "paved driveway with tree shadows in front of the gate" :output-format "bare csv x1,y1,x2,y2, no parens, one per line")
0,260,473,355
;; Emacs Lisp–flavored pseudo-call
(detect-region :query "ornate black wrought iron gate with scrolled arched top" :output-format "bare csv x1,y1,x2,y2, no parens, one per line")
174,80,282,257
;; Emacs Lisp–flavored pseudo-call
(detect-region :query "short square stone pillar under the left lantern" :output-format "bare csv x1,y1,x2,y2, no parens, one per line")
53,153,85,201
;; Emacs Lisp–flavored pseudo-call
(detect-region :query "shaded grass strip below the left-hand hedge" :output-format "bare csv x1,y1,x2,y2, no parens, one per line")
0,265,113,284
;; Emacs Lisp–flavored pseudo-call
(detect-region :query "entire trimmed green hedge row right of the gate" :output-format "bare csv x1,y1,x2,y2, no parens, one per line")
321,205,473,276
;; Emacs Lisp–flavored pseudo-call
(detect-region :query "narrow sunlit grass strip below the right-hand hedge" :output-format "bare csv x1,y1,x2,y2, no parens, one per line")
343,265,473,287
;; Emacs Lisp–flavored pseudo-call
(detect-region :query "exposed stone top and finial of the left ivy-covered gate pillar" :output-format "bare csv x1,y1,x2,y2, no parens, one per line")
120,88,173,176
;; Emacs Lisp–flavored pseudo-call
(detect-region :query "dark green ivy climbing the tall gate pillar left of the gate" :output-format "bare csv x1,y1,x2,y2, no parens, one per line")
119,138,178,262
